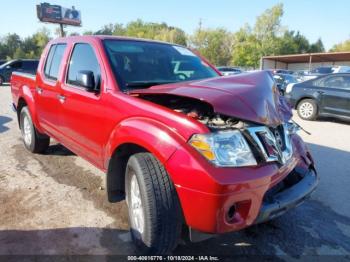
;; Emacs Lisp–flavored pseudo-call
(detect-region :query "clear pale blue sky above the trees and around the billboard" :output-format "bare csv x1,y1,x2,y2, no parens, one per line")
0,0,350,49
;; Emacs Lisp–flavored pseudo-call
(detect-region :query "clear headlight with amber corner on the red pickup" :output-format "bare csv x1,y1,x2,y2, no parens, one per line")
189,130,257,167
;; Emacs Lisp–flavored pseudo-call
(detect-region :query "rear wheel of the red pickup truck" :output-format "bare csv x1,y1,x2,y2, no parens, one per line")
19,106,50,153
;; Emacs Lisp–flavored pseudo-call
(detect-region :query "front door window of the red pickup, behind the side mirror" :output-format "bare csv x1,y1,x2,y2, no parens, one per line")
67,44,101,90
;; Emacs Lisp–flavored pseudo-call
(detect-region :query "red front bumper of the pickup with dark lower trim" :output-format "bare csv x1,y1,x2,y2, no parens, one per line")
165,136,317,234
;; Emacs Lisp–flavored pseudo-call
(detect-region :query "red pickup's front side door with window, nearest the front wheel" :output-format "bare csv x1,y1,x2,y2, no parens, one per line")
61,43,106,166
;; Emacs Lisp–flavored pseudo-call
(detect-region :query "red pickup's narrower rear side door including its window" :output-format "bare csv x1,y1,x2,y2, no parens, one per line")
35,44,66,139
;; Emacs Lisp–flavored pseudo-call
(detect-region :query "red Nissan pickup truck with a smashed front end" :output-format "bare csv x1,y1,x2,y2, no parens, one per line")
11,36,318,254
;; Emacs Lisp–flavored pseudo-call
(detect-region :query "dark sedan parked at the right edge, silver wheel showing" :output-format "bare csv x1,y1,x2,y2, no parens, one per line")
285,74,350,120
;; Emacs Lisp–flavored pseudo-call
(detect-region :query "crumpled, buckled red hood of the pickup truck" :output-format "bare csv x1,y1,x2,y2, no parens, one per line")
131,71,292,126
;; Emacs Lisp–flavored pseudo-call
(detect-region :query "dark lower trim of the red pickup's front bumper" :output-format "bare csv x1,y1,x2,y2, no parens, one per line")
254,169,318,224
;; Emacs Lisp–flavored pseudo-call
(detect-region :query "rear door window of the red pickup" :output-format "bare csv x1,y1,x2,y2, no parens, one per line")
44,44,66,80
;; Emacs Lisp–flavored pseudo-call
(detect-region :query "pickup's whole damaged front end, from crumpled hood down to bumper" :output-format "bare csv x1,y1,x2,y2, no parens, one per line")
132,72,318,236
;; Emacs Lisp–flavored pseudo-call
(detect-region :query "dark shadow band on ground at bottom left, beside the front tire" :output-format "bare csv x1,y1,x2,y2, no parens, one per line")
0,227,135,256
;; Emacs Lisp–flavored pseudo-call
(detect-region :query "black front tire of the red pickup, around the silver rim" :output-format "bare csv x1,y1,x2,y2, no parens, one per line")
125,153,182,254
